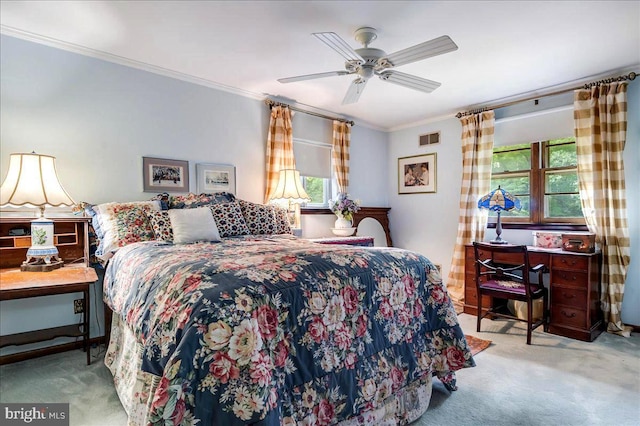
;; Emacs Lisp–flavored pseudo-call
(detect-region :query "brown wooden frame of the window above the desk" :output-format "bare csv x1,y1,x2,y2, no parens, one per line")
489,138,587,231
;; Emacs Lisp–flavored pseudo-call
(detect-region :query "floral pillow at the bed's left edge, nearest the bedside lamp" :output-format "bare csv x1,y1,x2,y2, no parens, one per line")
96,201,160,262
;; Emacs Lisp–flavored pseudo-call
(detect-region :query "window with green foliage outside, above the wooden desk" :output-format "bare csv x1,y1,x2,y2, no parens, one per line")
490,137,585,225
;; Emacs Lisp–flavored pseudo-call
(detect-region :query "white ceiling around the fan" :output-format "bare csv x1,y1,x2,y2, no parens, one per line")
0,0,640,130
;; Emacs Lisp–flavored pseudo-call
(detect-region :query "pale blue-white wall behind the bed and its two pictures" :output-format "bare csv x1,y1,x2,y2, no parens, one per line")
0,35,388,354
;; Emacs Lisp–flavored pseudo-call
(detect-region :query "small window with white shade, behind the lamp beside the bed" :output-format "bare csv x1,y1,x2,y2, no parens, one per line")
293,138,332,207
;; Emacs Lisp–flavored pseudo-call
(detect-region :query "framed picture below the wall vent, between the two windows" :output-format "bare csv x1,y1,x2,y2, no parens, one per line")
398,152,438,194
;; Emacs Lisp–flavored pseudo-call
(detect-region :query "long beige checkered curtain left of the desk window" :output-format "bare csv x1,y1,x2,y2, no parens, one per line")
447,111,495,312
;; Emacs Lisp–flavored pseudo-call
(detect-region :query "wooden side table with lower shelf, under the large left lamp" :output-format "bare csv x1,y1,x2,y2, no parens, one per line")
0,266,98,365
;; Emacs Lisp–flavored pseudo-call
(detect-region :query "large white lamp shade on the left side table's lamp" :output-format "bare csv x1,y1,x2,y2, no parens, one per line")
0,153,75,210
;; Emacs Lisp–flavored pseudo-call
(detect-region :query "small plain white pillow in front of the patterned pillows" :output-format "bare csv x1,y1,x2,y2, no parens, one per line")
169,207,220,244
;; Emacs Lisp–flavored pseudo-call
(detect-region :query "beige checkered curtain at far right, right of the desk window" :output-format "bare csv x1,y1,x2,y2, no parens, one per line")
573,82,631,337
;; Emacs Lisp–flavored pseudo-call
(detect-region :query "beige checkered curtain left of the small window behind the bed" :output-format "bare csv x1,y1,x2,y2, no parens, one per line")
264,105,296,203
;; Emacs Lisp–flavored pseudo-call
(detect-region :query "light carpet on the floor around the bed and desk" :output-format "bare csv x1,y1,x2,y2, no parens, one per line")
0,314,640,426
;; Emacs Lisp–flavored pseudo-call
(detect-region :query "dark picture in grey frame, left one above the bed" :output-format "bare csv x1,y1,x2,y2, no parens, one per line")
142,157,189,192
